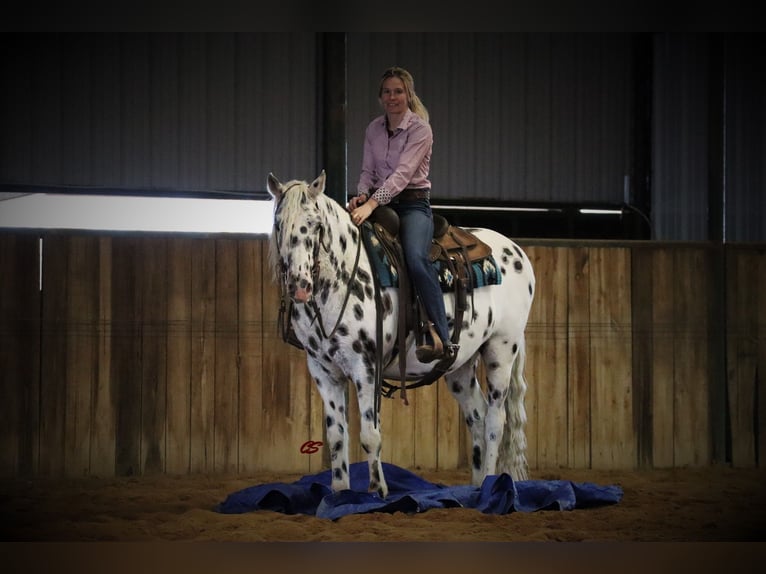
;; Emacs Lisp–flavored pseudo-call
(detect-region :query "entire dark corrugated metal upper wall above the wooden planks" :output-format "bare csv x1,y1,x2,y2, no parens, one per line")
0,32,766,241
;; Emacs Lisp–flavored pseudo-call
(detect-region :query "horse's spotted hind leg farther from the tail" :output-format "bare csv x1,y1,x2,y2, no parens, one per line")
444,357,487,486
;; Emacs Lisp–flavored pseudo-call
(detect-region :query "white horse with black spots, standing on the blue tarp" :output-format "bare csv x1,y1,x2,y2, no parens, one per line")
268,171,535,498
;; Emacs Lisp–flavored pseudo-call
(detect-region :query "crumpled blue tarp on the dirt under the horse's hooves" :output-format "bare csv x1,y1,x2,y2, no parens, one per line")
215,462,623,520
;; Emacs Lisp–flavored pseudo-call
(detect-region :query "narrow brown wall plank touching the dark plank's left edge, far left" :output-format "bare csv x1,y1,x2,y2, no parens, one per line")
90,237,117,476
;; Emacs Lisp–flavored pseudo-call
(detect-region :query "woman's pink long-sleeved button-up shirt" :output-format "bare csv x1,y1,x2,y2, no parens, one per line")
356,110,433,205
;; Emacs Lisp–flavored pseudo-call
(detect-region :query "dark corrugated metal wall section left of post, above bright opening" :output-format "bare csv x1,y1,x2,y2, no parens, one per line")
0,33,319,200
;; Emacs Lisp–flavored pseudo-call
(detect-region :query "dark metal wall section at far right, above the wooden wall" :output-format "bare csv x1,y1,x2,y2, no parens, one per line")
651,34,766,242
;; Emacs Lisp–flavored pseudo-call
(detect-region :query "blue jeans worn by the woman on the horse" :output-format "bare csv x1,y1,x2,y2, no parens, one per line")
389,198,450,344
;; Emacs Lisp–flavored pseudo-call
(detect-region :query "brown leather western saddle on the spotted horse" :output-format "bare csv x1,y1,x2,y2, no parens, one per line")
362,205,492,404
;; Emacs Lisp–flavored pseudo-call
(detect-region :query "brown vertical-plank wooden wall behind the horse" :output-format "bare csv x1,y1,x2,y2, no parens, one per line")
0,232,766,476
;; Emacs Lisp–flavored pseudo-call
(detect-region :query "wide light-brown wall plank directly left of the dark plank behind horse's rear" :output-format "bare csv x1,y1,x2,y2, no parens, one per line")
590,247,636,469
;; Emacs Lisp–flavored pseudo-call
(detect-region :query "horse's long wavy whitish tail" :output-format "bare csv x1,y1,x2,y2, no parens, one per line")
497,339,529,480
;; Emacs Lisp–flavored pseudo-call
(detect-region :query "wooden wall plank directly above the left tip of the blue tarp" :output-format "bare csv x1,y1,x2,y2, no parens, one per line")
214,239,239,473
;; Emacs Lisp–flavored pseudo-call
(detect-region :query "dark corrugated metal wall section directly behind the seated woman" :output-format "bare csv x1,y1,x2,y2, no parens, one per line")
347,33,633,203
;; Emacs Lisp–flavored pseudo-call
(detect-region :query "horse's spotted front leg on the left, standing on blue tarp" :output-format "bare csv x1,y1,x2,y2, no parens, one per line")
314,372,351,492
